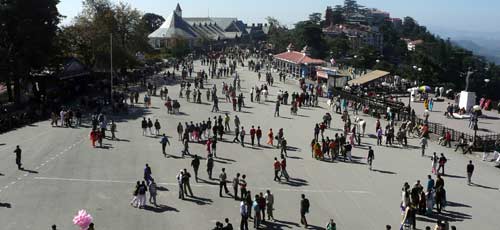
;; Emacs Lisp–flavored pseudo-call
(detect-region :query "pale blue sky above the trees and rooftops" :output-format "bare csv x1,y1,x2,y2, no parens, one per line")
58,0,500,34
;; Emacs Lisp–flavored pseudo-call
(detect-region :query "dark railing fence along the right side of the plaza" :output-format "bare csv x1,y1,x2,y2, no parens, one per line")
333,89,500,151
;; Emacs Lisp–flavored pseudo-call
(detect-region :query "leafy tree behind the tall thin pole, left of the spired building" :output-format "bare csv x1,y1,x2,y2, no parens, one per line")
62,0,151,72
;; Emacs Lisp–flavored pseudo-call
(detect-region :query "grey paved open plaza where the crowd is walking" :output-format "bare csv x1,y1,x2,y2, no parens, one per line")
0,59,500,230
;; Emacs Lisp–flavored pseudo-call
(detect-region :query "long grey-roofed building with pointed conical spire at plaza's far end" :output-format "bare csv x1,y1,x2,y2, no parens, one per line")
148,4,269,49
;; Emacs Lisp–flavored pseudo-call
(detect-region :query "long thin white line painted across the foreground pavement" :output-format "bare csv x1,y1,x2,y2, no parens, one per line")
33,177,373,195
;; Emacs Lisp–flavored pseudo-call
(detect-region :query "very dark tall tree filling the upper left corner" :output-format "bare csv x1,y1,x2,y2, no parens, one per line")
0,0,61,103
